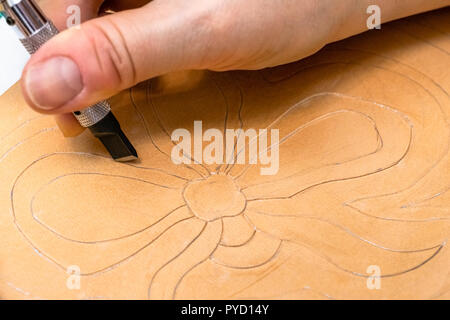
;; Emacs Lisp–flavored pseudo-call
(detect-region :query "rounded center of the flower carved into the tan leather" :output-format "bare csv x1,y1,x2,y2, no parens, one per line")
183,174,246,221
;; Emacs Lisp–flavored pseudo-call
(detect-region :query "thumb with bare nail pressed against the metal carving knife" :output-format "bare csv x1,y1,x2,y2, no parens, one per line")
22,0,213,114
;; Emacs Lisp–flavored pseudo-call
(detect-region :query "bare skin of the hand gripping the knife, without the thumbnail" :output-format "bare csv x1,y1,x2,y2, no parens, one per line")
22,0,450,136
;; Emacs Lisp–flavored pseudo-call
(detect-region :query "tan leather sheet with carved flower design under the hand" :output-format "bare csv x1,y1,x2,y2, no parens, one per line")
0,9,450,299
